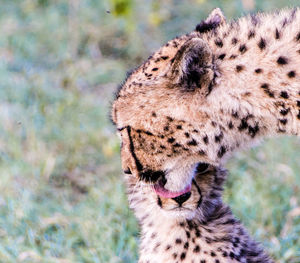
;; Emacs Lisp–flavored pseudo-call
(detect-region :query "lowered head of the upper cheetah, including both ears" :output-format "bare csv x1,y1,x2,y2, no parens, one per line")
112,9,230,197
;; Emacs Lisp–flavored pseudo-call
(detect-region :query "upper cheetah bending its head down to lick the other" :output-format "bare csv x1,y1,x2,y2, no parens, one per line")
112,8,300,196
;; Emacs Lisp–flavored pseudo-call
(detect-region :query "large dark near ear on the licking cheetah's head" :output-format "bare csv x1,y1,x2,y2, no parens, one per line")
172,38,214,96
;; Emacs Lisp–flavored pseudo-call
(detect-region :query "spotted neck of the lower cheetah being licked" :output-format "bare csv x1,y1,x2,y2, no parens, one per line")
128,178,273,263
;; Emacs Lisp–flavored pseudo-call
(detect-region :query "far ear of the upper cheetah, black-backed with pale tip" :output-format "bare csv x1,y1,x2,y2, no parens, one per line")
195,8,226,33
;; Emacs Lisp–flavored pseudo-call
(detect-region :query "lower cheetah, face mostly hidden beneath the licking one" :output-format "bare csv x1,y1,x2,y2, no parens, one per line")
125,163,274,263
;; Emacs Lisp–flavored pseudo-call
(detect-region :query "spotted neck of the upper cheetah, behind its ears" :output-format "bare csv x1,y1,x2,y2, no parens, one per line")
197,9,300,160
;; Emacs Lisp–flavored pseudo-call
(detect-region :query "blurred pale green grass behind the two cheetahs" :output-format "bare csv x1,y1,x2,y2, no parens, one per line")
0,0,300,263
